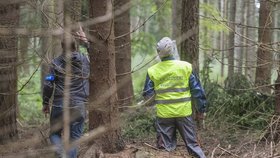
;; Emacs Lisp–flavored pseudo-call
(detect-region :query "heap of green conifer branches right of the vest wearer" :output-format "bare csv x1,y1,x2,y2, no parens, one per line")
205,75,274,129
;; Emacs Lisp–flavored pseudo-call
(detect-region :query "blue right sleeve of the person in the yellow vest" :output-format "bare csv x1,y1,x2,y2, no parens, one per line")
189,72,206,113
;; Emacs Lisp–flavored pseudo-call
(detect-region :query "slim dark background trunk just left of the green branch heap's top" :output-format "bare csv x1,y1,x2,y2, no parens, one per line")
228,1,236,78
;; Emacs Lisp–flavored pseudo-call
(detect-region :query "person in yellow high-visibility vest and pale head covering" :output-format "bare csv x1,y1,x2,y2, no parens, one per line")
143,37,206,158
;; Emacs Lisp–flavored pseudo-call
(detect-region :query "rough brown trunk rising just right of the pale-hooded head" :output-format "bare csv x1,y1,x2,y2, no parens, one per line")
180,0,199,73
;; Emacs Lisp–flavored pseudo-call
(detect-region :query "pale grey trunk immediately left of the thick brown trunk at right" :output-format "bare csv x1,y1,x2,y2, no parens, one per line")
245,0,257,83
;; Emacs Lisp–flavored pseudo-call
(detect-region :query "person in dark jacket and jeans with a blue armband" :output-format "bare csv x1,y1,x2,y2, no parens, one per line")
42,28,90,158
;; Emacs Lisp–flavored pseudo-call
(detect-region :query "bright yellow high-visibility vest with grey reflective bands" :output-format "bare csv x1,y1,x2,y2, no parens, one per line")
148,60,192,118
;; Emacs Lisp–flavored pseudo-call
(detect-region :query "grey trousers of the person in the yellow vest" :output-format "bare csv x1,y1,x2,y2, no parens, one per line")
155,116,205,158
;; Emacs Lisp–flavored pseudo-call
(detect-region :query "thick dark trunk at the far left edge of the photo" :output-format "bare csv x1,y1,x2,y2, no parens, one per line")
0,4,19,143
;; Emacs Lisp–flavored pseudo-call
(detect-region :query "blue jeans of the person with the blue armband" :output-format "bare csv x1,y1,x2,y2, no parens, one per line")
50,106,84,158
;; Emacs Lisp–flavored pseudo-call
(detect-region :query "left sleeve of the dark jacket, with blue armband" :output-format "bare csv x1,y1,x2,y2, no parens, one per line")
43,64,55,105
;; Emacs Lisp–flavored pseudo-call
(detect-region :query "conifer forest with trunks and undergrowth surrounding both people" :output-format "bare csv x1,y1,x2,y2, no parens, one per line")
0,0,280,157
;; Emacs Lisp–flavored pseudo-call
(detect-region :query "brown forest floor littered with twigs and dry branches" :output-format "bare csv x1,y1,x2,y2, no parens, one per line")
0,121,280,158
